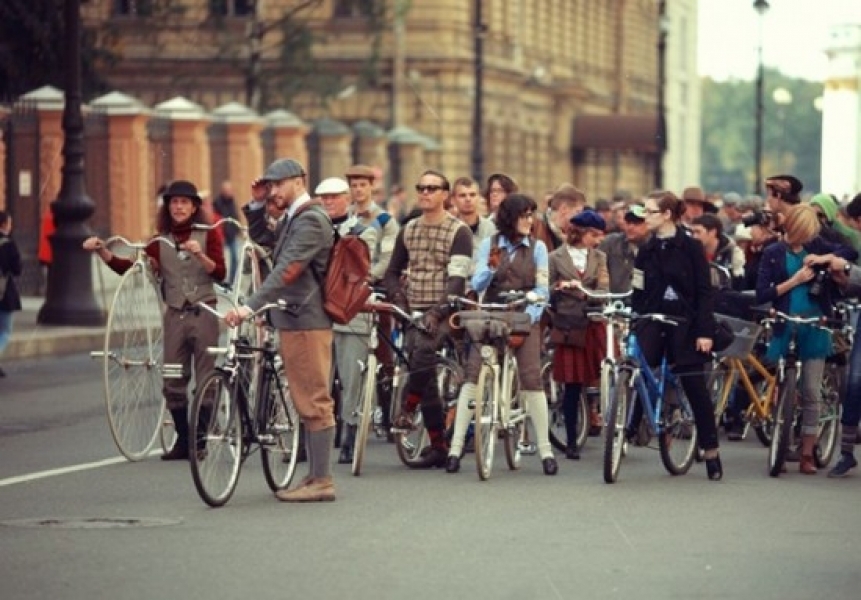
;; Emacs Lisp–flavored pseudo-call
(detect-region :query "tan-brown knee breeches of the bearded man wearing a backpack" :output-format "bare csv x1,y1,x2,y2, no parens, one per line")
279,329,335,432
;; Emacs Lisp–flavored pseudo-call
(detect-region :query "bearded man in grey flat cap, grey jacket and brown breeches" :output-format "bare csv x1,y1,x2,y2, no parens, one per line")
225,158,335,502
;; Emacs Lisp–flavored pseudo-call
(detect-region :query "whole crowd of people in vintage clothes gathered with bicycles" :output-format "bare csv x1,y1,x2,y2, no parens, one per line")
63,159,861,502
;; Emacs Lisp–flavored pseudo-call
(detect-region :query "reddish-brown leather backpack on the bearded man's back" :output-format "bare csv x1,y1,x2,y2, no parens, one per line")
294,204,371,325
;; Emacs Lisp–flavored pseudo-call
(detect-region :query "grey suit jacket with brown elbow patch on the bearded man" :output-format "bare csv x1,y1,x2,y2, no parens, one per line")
248,202,334,331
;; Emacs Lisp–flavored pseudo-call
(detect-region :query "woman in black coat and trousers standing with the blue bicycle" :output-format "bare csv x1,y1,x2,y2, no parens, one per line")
631,192,723,481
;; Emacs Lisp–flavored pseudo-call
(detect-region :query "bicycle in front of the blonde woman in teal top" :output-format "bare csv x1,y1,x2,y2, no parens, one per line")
763,310,846,477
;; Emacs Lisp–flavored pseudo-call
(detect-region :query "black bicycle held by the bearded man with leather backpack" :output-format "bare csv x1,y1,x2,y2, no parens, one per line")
189,303,299,507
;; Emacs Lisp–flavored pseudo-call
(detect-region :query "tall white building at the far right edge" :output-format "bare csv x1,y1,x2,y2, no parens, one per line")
821,23,861,199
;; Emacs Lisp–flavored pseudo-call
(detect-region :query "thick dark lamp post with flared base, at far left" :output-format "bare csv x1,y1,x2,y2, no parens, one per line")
38,0,104,325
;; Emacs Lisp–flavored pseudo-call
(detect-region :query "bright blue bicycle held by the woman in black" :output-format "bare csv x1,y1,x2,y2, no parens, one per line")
603,312,697,483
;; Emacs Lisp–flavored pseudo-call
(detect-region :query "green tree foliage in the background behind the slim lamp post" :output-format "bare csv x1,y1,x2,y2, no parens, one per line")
700,69,822,193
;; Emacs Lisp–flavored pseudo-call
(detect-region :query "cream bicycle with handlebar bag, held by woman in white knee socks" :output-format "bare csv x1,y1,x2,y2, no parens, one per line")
450,292,541,481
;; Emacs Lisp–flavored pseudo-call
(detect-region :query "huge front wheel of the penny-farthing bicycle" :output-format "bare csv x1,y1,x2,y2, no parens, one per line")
102,262,164,461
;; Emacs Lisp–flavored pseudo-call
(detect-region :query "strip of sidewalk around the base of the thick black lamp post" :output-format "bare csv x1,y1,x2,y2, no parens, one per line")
5,296,105,363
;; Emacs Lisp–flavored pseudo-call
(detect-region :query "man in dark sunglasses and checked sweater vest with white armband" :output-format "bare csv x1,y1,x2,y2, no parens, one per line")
384,170,472,468
